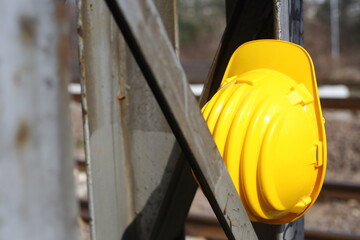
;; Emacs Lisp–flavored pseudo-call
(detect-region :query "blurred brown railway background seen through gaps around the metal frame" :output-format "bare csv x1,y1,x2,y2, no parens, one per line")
66,0,360,239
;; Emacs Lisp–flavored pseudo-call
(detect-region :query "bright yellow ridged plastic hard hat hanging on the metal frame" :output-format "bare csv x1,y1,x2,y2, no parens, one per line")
202,40,326,224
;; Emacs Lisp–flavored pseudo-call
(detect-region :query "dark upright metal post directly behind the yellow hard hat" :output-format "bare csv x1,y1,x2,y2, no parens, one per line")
224,0,304,240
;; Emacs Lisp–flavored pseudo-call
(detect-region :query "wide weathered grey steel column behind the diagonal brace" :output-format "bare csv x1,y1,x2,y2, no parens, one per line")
79,0,197,239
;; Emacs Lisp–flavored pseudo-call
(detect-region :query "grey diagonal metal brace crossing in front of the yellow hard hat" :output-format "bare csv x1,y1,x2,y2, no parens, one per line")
105,0,257,239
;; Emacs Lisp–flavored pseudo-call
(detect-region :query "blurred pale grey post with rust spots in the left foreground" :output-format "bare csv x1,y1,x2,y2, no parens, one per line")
0,0,79,240
